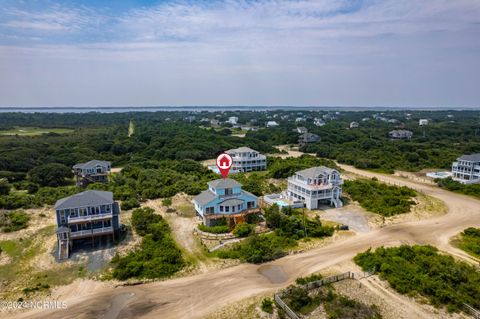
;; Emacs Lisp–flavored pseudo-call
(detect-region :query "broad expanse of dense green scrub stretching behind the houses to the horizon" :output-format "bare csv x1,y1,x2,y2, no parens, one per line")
0,110,480,209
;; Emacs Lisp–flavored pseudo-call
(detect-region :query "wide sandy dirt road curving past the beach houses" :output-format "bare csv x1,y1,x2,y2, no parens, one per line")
8,165,480,319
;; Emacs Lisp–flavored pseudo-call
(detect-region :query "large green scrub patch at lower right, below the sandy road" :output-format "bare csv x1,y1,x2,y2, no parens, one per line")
354,245,480,312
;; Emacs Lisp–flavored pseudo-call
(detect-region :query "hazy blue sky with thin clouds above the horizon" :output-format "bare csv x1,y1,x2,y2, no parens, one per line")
0,0,480,108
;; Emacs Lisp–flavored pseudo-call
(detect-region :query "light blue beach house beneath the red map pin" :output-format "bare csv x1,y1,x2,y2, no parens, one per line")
193,178,260,226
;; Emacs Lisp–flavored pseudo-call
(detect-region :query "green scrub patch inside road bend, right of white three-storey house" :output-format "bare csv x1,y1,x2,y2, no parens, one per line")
343,178,417,217
